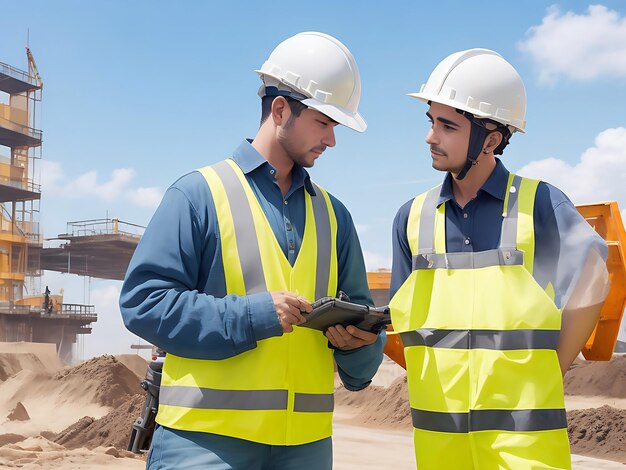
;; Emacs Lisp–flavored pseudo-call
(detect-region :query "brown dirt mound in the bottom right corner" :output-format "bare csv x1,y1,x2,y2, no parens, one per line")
567,405,626,462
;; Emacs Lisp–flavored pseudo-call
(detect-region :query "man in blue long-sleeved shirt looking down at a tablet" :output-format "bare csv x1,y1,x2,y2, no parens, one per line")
120,32,384,470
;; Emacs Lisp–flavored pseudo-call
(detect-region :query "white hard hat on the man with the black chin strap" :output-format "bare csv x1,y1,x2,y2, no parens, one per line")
409,49,526,132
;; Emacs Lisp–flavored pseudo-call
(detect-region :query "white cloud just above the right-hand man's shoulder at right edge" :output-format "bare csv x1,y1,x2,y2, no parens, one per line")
518,127,626,206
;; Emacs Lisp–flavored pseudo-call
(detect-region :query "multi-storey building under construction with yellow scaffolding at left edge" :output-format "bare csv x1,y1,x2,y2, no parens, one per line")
0,48,97,362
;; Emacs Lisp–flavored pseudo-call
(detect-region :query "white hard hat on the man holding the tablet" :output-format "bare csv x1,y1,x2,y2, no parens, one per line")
256,32,367,132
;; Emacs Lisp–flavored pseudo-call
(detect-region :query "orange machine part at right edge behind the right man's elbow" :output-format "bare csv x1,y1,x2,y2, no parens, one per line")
576,202,626,361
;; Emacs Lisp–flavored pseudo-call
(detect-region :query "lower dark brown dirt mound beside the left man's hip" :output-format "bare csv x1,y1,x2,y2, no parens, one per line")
53,394,145,449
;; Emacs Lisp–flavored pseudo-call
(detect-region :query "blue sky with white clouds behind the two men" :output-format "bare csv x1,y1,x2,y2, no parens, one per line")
0,0,626,356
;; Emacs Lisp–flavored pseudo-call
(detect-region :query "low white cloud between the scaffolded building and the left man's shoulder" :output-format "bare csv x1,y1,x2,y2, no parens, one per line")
41,160,163,209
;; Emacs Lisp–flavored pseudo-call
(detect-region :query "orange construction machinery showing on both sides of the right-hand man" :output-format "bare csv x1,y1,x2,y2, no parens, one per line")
367,198,626,369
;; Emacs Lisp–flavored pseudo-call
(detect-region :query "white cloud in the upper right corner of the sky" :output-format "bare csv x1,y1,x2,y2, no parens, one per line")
518,5,626,83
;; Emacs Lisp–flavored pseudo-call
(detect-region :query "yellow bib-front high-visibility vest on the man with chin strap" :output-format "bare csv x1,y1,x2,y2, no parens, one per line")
390,174,571,470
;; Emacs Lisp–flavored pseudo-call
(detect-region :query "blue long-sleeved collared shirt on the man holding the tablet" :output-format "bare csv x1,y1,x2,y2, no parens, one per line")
120,141,385,390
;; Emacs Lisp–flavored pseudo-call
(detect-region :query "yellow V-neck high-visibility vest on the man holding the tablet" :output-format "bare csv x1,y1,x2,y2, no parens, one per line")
156,160,337,445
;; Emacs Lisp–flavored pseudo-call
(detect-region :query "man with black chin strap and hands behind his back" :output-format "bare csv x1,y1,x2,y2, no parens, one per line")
390,49,608,470
